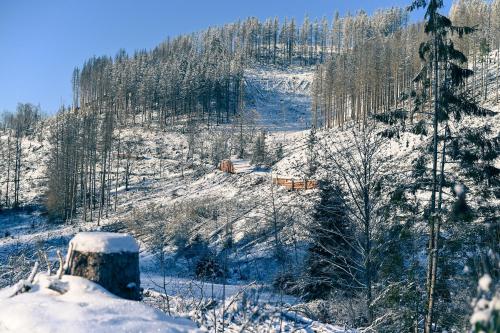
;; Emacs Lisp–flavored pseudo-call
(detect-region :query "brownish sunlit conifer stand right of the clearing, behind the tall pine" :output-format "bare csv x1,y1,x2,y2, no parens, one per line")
312,0,500,128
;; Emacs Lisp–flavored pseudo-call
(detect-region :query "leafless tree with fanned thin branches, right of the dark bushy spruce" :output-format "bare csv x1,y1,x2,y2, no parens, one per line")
319,122,394,325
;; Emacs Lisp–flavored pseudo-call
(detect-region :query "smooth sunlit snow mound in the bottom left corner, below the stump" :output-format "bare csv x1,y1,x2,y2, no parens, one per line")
0,274,199,333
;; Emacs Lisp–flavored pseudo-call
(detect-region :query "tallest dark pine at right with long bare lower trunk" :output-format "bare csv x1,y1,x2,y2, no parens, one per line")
409,0,492,333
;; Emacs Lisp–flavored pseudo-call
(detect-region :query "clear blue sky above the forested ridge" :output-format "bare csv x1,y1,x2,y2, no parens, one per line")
0,0,452,114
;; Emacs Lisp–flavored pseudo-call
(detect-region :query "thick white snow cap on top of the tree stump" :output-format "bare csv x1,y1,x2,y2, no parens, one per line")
69,232,139,253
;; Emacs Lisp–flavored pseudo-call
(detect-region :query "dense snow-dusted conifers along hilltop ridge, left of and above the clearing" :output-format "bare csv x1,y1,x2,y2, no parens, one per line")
73,9,407,127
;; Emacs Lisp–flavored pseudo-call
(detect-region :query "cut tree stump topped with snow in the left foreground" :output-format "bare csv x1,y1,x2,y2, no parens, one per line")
65,232,141,300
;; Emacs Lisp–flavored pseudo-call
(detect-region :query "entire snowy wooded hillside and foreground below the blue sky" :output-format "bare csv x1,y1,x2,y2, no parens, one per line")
0,0,500,333
